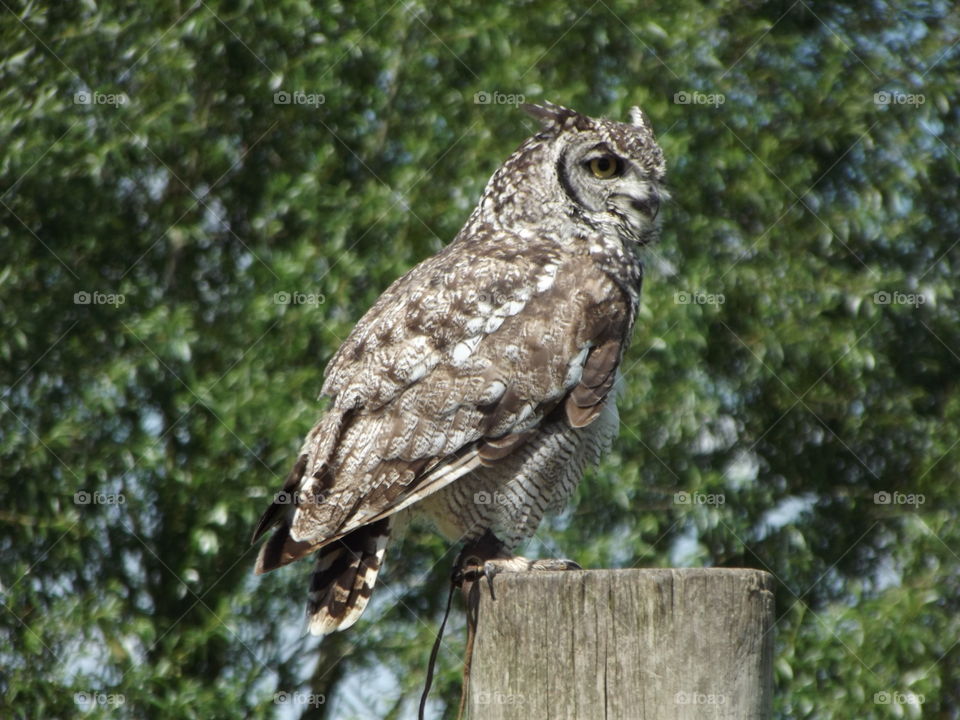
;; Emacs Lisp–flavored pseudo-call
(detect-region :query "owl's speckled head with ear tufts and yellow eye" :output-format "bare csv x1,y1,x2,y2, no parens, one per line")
523,103,667,248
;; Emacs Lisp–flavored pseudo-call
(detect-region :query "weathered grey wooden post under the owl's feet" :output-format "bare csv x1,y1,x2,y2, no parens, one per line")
467,568,774,720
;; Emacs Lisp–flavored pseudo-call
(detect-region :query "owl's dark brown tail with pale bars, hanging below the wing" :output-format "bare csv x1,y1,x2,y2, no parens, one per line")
307,518,390,635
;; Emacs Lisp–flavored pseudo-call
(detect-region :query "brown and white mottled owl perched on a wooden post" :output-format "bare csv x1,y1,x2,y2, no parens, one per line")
254,103,666,635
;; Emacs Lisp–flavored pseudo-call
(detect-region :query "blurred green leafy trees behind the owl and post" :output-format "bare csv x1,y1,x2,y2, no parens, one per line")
0,0,960,719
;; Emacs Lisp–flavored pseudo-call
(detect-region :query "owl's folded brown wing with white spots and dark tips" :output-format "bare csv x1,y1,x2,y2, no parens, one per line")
254,238,634,572
